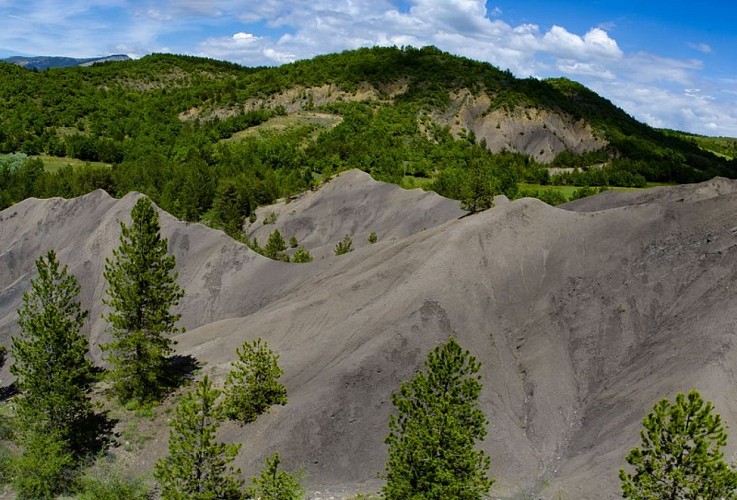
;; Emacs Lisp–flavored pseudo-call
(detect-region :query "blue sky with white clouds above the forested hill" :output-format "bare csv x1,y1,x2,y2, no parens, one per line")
0,0,737,137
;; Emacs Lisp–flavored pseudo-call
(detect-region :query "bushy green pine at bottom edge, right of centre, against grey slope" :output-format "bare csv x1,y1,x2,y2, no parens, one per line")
383,338,493,500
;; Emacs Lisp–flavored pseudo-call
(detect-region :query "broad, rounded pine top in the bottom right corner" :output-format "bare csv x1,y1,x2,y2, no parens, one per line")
619,390,737,499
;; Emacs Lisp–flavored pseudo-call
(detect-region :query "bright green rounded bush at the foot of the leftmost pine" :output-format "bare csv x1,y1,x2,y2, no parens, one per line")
11,432,76,499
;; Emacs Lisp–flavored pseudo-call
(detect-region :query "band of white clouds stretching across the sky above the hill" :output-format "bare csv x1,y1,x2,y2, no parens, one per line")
0,0,737,135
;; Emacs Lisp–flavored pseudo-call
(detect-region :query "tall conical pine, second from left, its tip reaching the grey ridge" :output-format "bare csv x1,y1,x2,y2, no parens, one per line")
102,198,184,402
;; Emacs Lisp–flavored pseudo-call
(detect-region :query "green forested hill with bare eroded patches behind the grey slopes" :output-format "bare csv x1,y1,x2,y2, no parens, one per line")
0,47,737,229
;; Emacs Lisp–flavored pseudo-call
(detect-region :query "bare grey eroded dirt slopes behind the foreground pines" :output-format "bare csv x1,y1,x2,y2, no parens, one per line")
0,173,737,498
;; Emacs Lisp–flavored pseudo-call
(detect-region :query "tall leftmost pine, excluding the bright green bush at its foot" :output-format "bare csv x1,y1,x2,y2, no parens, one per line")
10,251,93,453
